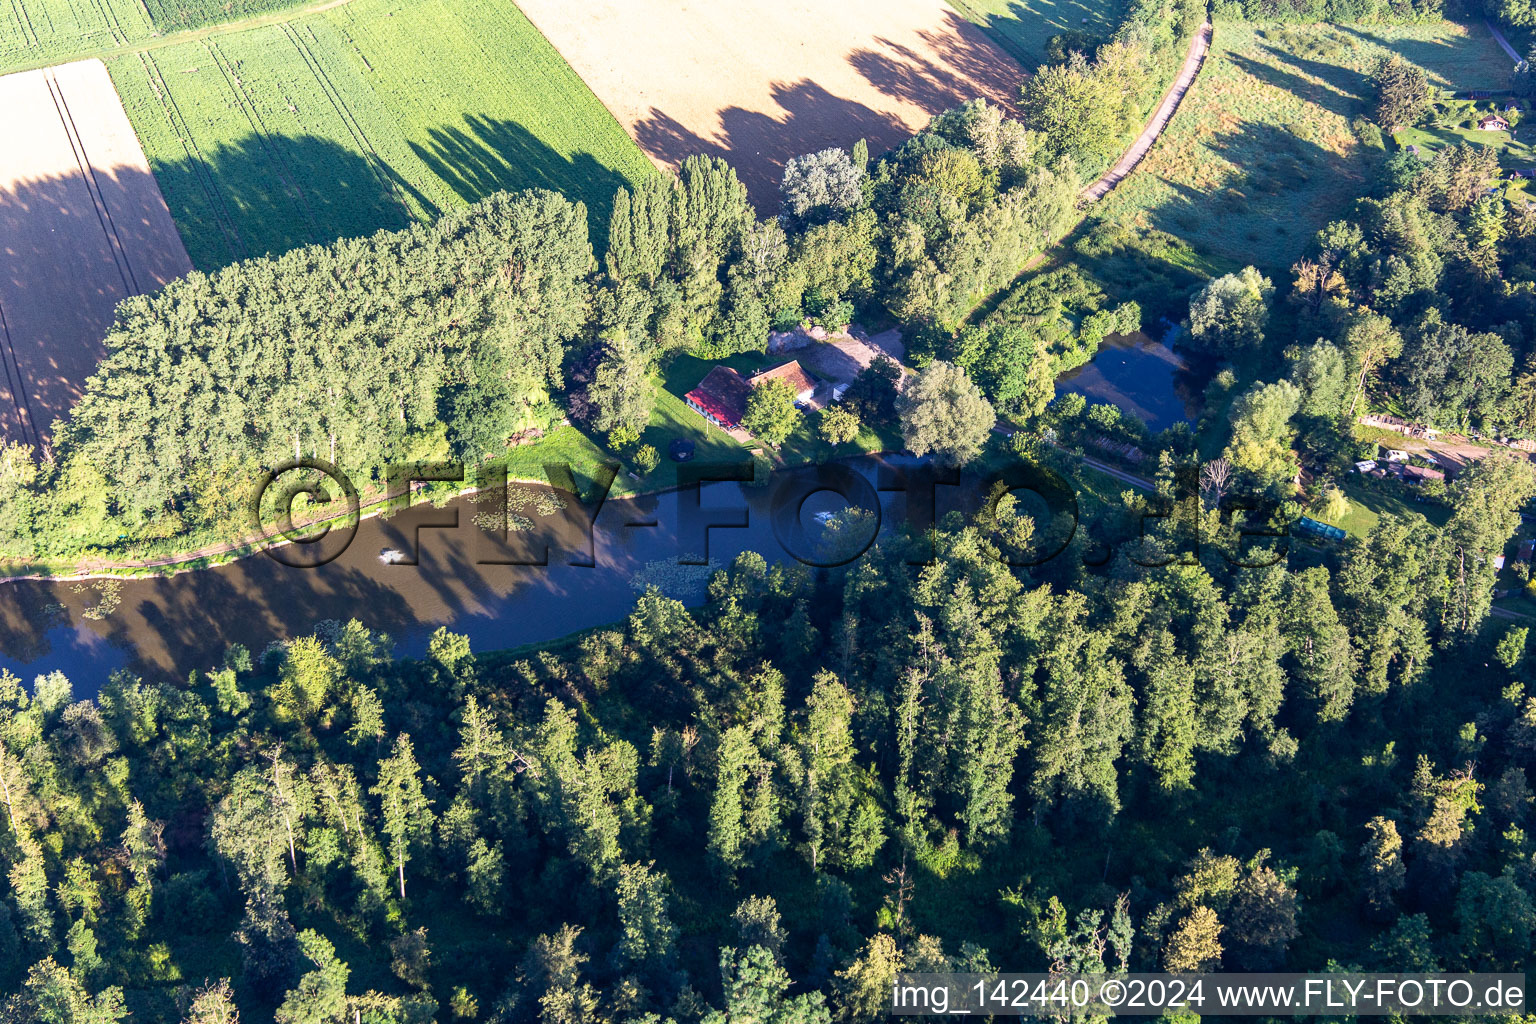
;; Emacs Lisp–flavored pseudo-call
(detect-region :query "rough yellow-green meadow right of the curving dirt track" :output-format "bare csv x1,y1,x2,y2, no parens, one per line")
1094,21,1508,275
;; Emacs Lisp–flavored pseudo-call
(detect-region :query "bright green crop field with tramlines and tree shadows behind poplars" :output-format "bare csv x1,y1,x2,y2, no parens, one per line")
108,0,653,270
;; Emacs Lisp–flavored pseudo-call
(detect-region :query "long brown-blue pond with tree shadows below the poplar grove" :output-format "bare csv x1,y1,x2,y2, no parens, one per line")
0,459,943,695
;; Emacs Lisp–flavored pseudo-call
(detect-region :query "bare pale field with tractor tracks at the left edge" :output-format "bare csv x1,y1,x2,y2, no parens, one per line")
0,60,192,445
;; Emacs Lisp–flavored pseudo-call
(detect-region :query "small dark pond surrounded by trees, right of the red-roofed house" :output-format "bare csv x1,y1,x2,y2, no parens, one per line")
1057,332,1200,431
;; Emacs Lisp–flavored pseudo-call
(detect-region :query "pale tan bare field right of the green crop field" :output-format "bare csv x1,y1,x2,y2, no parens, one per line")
519,0,1025,205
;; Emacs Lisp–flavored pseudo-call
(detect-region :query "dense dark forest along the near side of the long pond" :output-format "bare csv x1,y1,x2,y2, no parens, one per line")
0,456,1536,1024
